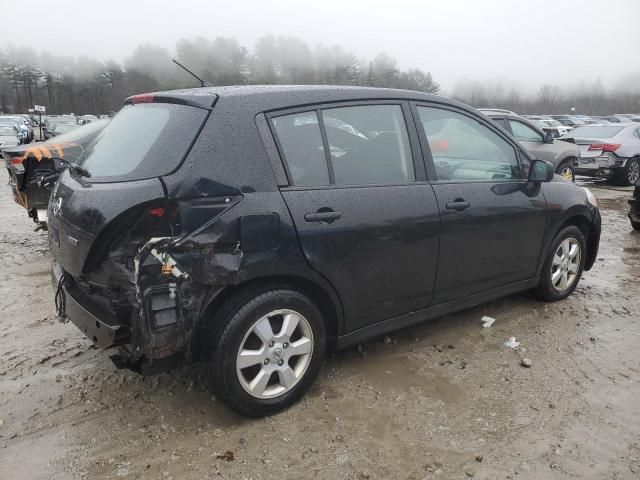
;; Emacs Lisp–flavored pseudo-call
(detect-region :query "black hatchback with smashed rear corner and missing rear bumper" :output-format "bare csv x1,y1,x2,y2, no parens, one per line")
48,86,600,416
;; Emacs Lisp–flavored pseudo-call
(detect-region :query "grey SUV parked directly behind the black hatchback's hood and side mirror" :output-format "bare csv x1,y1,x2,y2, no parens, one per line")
479,109,580,181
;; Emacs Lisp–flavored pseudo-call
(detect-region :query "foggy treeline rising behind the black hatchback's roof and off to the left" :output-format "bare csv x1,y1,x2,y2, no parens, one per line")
0,35,440,114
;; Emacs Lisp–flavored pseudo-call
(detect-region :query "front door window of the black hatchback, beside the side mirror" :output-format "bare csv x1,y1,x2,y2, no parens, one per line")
418,106,522,182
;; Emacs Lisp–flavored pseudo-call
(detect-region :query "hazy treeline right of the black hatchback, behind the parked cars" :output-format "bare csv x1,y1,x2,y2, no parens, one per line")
451,75,640,115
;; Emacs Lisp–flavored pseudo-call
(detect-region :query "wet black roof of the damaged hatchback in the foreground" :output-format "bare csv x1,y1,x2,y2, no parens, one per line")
131,85,474,113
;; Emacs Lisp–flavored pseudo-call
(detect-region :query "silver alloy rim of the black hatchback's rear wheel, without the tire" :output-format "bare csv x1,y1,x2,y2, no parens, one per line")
236,309,314,399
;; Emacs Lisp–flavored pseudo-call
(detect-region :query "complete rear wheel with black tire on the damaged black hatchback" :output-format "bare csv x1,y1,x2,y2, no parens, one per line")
208,287,326,417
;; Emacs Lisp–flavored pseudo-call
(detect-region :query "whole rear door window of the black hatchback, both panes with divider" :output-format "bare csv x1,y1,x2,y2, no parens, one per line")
271,105,415,186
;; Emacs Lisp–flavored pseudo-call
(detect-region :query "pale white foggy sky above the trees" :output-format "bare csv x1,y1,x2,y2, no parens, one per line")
0,0,640,90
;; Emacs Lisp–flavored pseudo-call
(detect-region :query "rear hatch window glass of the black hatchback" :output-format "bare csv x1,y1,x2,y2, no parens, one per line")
78,103,208,182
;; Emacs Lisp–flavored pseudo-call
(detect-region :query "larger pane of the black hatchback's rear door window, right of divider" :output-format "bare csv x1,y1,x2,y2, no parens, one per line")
322,105,415,185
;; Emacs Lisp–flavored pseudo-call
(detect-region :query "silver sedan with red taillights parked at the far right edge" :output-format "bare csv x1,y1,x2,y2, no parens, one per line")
562,123,640,185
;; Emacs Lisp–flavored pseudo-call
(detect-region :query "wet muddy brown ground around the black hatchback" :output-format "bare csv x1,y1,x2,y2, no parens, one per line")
0,166,640,479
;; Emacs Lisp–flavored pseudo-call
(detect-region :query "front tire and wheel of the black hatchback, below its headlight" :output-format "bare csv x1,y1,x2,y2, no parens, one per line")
534,225,587,302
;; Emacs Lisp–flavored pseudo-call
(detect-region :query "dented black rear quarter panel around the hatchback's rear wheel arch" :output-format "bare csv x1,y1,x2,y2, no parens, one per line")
163,97,342,338
